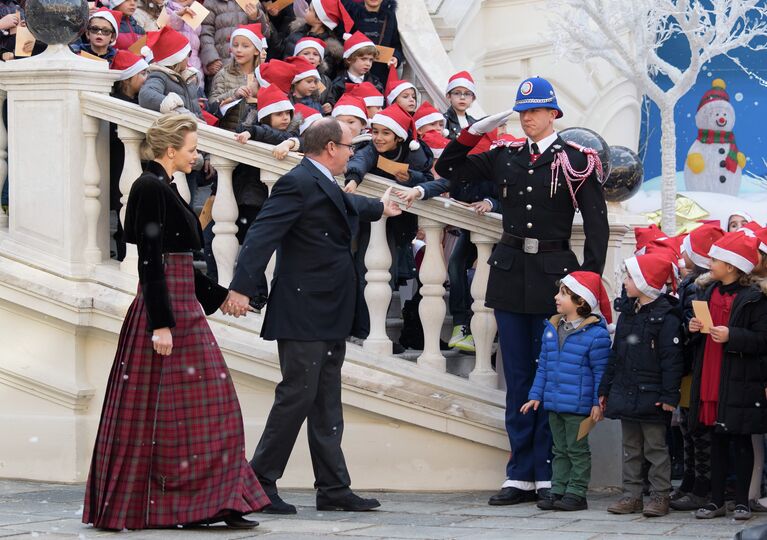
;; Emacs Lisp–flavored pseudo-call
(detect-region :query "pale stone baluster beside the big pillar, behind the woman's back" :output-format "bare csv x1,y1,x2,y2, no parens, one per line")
83,116,101,264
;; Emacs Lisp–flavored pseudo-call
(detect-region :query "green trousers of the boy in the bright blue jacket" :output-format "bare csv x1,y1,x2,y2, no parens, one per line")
549,412,591,497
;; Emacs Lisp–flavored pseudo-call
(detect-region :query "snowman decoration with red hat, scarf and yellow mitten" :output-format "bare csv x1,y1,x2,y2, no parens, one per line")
684,79,746,196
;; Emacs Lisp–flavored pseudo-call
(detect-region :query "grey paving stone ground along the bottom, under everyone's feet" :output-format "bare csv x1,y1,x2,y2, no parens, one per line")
0,480,767,540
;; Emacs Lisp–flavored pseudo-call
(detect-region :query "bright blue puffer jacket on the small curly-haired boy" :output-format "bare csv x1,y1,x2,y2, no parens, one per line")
528,315,611,416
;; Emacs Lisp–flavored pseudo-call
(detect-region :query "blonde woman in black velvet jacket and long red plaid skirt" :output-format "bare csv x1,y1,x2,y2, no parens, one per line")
83,115,269,530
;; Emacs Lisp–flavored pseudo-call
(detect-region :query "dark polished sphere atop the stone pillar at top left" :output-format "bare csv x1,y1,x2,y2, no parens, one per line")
25,0,88,45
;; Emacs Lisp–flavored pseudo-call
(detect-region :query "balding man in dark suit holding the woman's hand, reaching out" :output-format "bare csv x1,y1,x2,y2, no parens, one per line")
225,118,401,514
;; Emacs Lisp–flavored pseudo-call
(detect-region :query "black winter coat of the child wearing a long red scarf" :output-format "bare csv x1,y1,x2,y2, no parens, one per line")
689,273,767,433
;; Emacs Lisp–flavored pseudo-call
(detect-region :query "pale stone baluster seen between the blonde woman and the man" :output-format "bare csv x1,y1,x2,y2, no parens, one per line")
210,155,240,287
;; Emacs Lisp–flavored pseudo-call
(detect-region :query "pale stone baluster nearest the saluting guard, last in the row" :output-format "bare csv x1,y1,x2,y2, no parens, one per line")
469,232,498,388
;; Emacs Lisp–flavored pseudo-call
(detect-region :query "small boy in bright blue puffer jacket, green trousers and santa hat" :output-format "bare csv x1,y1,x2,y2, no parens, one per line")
521,272,612,511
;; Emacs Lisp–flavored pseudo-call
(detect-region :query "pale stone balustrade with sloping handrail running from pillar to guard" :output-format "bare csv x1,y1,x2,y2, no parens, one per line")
80,92,508,388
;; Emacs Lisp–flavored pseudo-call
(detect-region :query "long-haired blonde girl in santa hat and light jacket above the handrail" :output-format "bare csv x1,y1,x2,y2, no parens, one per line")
209,23,266,131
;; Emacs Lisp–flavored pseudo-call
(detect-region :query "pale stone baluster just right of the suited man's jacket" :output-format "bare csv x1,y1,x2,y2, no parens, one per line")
362,217,392,355
